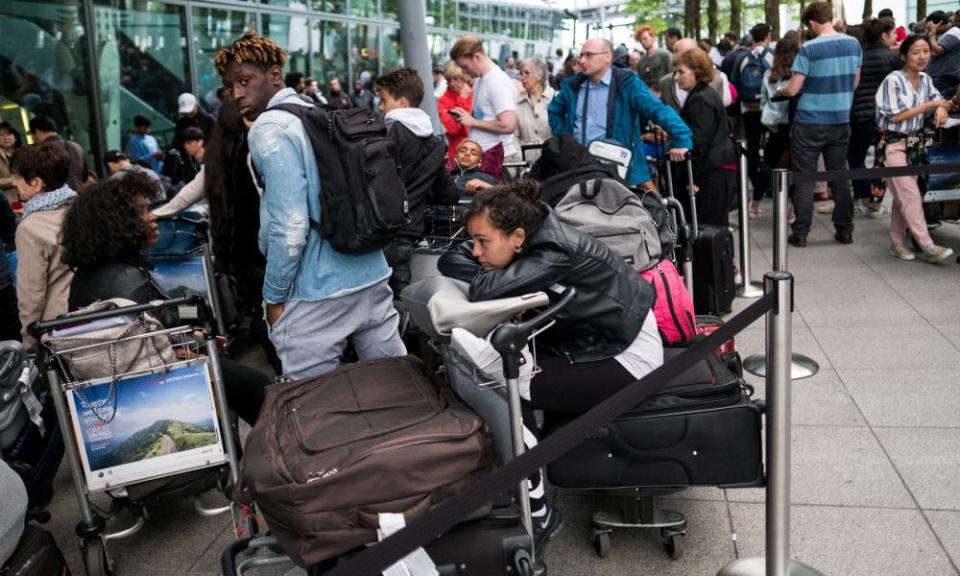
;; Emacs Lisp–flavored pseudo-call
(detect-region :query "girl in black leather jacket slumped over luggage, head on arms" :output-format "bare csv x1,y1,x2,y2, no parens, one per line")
439,180,663,538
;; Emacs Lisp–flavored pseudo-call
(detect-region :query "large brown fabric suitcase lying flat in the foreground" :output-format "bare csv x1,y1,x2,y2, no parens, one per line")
242,356,495,566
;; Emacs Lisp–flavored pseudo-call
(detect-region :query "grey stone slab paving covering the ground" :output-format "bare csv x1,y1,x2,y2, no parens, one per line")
48,199,960,576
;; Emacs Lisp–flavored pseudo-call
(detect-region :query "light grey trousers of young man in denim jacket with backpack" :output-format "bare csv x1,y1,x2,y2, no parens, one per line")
269,278,407,380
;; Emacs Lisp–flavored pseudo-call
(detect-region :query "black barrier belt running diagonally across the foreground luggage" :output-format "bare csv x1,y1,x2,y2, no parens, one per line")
325,290,777,576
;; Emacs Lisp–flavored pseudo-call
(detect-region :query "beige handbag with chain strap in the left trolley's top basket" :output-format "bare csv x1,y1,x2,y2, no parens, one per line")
42,298,176,390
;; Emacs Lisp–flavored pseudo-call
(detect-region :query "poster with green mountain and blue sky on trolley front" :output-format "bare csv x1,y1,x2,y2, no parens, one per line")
70,362,224,490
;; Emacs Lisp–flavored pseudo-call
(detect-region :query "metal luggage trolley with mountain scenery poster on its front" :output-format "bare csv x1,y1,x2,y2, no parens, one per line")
29,295,249,576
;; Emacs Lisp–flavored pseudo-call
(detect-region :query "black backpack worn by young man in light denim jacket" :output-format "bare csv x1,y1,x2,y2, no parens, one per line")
271,104,410,254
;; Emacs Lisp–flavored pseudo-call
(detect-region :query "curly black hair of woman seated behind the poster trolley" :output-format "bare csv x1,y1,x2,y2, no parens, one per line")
60,172,156,270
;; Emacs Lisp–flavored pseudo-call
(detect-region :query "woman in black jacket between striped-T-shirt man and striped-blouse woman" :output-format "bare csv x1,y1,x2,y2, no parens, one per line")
847,18,903,217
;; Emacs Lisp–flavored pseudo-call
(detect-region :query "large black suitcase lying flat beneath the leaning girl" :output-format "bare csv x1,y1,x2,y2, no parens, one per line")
547,348,763,489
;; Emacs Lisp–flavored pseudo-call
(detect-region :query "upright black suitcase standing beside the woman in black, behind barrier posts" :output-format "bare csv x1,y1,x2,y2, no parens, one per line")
693,225,737,316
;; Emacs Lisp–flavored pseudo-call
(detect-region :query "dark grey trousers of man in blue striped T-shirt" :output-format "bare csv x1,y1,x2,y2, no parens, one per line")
790,123,853,236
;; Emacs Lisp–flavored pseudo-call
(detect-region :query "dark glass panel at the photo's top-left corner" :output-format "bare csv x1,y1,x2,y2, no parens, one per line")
0,0,94,158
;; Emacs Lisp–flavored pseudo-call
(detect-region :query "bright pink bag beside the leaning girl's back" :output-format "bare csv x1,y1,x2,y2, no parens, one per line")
640,258,697,346
